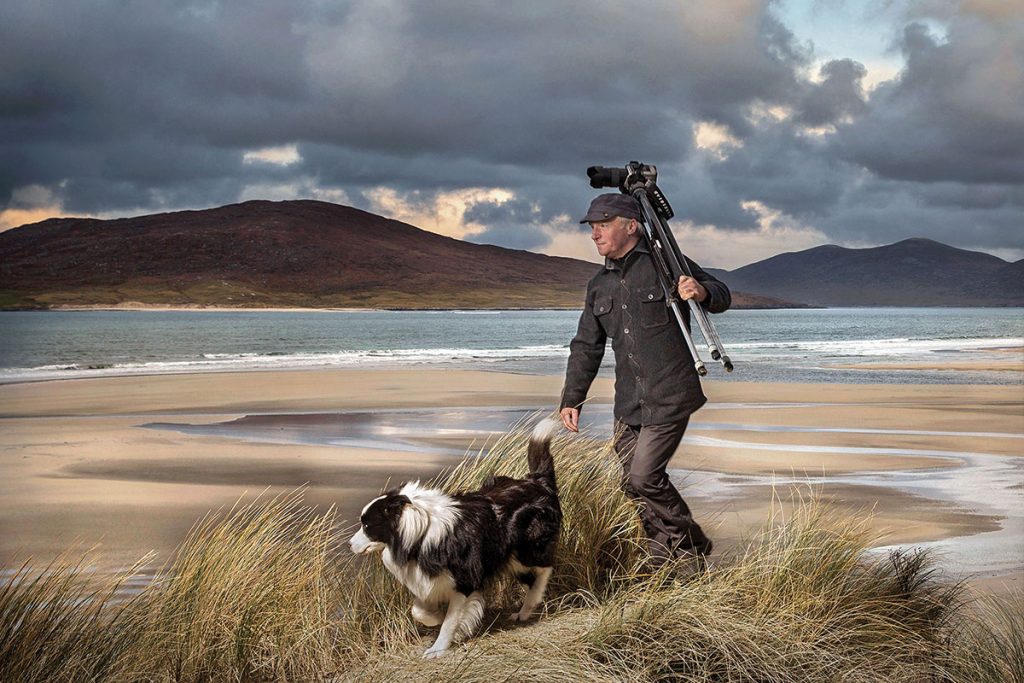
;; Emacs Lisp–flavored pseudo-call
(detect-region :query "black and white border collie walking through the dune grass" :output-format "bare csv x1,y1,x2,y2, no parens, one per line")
349,420,562,657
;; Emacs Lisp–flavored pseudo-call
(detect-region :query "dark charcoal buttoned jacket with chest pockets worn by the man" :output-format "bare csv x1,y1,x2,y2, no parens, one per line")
559,240,732,426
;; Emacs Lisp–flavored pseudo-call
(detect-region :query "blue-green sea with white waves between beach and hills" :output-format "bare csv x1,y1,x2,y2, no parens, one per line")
0,308,1024,384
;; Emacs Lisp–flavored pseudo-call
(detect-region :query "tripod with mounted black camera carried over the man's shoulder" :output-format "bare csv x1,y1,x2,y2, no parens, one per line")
587,161,732,377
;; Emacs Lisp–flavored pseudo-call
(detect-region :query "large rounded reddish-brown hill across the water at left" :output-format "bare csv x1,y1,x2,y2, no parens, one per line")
0,201,787,308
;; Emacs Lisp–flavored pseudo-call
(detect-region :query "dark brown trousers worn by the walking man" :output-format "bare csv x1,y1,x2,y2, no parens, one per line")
615,418,711,560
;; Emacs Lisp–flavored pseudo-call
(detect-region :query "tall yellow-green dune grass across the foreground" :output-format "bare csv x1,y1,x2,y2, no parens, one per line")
0,419,1024,683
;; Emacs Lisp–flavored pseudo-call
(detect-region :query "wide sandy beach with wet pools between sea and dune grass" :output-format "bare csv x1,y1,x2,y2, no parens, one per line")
0,369,1024,592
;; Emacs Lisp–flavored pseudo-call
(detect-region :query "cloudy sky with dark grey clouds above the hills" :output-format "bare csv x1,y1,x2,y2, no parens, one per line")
0,0,1024,268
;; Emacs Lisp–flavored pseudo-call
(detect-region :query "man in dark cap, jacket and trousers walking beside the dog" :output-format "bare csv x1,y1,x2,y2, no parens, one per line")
560,195,732,564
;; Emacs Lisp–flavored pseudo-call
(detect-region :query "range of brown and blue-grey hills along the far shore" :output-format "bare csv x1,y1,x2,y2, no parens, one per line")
0,201,1024,309
